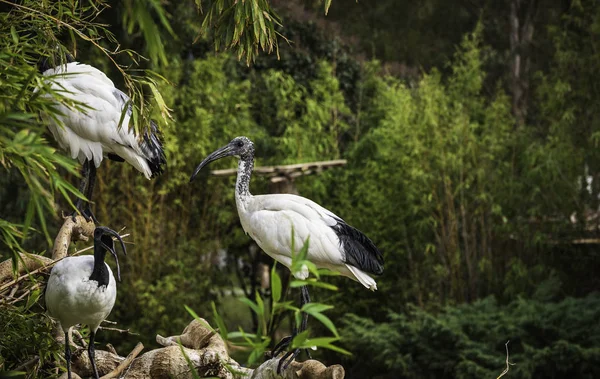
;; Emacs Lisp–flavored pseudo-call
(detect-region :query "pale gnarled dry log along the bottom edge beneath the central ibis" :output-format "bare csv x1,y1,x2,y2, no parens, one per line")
59,320,344,379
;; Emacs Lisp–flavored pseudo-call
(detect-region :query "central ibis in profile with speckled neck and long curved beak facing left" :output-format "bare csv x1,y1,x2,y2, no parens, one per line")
190,137,383,370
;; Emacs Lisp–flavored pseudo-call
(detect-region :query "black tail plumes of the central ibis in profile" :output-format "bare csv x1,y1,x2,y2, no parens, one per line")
331,219,383,275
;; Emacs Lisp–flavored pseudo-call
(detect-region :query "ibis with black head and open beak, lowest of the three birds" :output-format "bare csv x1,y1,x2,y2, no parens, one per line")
45,226,127,379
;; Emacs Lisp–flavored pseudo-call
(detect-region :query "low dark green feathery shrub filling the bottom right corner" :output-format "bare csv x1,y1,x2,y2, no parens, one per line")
342,294,600,378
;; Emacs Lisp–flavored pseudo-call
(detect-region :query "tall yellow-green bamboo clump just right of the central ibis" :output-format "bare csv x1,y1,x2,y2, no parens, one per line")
338,26,517,302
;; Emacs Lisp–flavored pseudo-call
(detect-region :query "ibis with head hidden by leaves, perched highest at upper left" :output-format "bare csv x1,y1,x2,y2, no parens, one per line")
40,55,166,222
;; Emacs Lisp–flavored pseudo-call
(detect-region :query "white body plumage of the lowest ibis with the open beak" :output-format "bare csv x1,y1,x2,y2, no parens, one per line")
45,255,117,332
